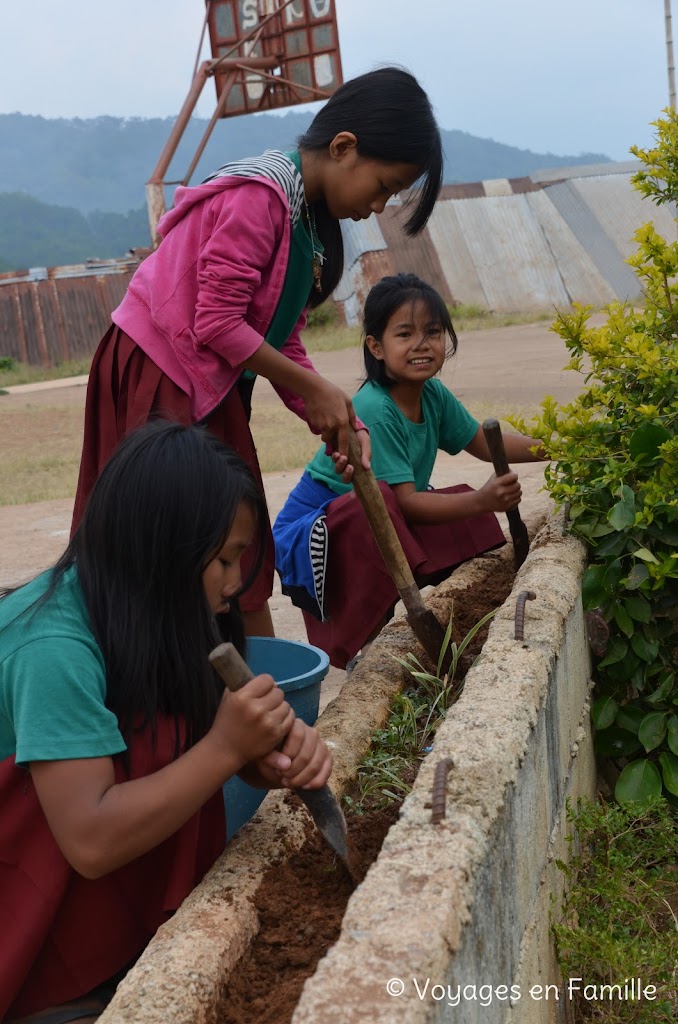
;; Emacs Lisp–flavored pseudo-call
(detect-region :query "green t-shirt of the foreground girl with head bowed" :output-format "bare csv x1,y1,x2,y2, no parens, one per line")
0,567,126,764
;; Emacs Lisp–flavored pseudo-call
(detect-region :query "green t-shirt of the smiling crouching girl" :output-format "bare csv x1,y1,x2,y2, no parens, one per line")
306,378,478,495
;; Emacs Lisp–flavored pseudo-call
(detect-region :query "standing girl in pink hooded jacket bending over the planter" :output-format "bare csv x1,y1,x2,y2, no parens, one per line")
72,68,442,636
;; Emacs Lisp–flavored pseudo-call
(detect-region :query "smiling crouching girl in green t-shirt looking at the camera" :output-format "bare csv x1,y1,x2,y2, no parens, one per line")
273,273,543,669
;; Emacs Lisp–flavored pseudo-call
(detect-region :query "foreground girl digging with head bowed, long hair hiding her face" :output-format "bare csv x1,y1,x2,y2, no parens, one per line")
0,422,332,1024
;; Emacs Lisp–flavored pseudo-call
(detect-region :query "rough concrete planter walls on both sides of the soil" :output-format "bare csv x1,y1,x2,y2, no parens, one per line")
99,505,595,1024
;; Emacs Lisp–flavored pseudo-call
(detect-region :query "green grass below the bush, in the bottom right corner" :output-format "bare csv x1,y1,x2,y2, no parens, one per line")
554,800,678,1024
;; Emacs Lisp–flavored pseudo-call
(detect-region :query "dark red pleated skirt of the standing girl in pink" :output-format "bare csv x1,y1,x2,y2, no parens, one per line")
71,325,274,611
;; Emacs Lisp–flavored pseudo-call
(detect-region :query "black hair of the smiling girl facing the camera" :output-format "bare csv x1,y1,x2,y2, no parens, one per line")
363,273,457,387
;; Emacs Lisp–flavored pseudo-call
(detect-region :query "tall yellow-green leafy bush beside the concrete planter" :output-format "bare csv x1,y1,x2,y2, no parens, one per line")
511,111,678,803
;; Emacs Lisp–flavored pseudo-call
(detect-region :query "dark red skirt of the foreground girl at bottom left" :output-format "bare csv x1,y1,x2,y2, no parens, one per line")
0,718,226,1020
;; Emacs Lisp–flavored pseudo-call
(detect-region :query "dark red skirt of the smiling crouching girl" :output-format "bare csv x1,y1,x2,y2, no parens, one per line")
303,481,506,669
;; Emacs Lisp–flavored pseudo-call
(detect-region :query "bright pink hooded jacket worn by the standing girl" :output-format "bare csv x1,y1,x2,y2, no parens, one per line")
112,175,313,422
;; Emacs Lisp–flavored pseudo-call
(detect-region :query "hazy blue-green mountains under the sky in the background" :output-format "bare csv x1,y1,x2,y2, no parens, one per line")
0,111,608,267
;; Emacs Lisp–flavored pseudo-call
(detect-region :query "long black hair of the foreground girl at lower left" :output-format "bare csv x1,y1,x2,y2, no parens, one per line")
2,421,266,754
